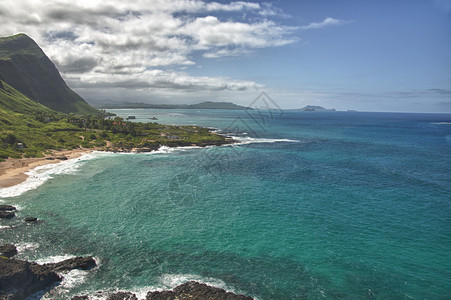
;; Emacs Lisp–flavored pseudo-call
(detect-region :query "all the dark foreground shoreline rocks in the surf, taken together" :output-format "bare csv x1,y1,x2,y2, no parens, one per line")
0,205,253,300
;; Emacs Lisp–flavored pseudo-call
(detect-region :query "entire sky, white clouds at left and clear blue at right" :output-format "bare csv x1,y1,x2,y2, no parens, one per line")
0,0,451,113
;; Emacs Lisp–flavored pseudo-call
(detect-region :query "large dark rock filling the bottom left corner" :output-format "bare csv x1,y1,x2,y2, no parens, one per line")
0,258,61,299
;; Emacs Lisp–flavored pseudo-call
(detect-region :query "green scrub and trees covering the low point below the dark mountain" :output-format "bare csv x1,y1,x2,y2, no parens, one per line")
0,80,229,160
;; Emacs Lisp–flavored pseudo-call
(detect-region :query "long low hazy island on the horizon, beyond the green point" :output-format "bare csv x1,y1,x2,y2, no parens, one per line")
96,101,250,110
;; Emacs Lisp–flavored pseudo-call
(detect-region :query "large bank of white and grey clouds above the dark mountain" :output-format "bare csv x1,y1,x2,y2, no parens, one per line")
0,0,300,102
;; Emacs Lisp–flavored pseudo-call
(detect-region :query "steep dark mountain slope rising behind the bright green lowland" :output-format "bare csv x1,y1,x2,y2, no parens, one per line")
0,34,99,115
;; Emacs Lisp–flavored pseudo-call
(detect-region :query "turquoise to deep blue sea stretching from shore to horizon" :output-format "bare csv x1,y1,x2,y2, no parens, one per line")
0,110,451,299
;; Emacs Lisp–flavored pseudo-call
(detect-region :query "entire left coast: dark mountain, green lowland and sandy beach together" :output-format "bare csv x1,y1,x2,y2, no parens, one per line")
0,34,232,186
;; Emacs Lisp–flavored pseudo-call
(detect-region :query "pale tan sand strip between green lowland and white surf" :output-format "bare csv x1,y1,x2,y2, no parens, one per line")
0,148,100,188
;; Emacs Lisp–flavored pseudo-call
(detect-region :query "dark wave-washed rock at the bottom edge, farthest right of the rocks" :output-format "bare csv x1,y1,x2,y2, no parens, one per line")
146,281,252,300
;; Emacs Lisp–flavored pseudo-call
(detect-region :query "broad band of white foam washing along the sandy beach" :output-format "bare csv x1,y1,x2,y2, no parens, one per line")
0,152,103,198
